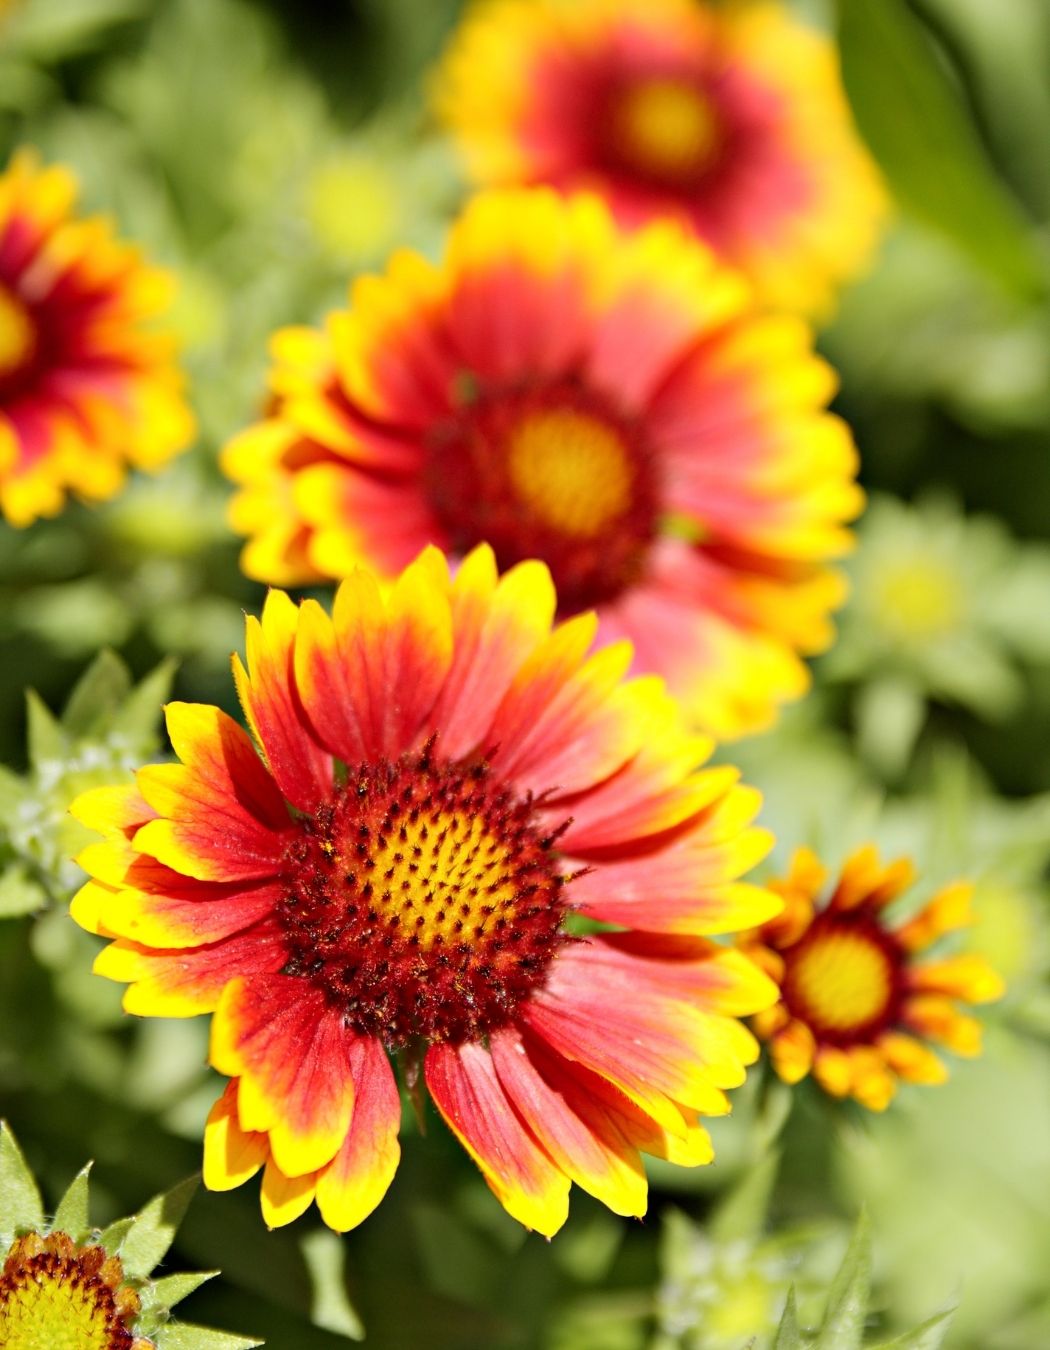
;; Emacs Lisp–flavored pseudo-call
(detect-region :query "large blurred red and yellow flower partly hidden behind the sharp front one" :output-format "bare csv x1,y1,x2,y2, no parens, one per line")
223,188,862,736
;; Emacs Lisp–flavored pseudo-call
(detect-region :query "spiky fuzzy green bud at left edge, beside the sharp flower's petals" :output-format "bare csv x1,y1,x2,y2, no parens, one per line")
0,651,174,919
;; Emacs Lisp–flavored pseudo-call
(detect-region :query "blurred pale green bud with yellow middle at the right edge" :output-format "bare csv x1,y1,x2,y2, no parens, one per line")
823,495,1050,768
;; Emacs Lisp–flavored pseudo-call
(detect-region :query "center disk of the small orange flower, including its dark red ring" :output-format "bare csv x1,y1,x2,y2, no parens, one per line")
783,921,896,1041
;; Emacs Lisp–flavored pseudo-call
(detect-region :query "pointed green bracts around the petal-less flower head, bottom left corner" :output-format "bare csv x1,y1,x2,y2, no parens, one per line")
0,1121,263,1350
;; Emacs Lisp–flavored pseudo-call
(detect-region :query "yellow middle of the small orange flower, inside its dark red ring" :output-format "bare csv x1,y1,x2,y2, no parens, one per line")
791,930,892,1031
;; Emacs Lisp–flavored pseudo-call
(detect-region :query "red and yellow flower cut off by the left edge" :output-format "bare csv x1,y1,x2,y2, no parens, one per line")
0,151,193,525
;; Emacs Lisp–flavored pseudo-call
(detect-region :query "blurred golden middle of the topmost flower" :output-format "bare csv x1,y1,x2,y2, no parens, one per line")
613,77,719,178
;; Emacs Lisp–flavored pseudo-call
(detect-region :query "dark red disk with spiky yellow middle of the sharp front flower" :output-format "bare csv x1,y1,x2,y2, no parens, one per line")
279,748,565,1049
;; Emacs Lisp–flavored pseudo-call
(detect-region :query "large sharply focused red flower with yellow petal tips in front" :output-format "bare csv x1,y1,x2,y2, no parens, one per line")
73,548,779,1234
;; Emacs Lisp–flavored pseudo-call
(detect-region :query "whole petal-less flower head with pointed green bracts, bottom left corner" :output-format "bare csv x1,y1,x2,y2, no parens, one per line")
0,1123,262,1350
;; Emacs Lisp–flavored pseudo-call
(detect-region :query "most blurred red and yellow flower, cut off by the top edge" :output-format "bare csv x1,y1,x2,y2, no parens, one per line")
436,0,884,313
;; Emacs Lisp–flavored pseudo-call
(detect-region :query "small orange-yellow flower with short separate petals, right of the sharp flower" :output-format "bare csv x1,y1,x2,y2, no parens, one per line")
741,845,1003,1111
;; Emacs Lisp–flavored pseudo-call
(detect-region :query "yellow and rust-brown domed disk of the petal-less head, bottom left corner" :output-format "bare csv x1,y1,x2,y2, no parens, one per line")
0,1233,144,1350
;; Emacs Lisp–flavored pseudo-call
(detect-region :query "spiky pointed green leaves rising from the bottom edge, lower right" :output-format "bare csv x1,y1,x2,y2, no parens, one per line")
773,1214,954,1350
